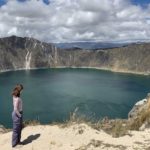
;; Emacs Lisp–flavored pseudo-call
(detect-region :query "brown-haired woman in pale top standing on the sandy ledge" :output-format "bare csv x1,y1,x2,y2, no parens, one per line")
12,84,23,147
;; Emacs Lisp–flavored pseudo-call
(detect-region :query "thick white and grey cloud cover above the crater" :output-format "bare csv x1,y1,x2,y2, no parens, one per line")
0,0,150,42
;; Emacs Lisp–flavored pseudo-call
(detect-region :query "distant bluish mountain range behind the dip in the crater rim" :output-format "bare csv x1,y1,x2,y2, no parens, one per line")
53,42,128,49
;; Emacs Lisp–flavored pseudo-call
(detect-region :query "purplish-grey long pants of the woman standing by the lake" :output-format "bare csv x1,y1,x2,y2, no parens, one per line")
12,111,23,147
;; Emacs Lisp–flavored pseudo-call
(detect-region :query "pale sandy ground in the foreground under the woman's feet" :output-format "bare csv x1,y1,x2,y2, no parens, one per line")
0,123,150,150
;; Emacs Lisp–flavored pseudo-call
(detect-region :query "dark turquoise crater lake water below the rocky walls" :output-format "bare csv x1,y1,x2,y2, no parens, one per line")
0,68,150,127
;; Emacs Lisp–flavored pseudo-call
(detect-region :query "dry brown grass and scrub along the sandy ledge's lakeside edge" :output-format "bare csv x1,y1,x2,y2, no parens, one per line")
3,101,150,137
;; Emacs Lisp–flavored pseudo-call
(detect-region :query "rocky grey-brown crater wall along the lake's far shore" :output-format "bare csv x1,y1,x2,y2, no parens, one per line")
0,36,150,74
